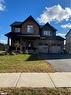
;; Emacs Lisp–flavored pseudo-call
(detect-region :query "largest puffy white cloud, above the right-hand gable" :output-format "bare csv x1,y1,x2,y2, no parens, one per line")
37,4,71,24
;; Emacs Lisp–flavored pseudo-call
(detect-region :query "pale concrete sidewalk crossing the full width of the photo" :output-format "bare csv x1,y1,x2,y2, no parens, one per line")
0,72,71,88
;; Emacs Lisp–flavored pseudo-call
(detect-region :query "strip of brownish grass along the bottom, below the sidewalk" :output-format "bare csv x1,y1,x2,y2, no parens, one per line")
0,88,71,95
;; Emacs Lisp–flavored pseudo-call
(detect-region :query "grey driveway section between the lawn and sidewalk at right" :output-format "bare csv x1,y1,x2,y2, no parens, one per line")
47,59,71,72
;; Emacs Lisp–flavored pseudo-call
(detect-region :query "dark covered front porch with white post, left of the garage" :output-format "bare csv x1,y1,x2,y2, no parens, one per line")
6,32,40,53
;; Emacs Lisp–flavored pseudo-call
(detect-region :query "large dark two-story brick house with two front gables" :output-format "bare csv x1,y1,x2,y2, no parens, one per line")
5,16,64,53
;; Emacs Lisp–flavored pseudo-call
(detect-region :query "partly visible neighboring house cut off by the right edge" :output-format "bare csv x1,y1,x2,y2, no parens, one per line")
66,29,71,53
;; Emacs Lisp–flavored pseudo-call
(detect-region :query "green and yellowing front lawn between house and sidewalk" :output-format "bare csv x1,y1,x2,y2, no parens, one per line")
0,54,54,73
